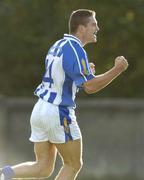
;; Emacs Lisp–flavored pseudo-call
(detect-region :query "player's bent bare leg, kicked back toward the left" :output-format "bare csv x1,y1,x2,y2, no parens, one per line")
2,142,57,180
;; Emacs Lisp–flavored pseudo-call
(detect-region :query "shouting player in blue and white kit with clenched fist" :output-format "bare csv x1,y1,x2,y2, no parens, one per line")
1,9,128,180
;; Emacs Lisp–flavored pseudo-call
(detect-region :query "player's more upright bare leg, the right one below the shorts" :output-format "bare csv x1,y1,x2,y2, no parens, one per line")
55,139,82,180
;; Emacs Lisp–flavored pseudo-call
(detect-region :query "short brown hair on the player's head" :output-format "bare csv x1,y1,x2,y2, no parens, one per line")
69,9,96,33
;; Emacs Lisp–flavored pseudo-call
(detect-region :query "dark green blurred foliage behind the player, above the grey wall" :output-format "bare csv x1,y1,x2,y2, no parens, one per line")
0,0,144,98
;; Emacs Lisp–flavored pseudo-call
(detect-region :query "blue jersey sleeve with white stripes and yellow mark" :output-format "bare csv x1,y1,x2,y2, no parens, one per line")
63,41,95,87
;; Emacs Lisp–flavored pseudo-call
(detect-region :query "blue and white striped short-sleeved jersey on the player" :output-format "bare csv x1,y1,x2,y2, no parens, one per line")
34,34,94,107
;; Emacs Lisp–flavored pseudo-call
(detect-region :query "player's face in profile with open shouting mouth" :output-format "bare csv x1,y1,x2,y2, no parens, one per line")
84,16,99,44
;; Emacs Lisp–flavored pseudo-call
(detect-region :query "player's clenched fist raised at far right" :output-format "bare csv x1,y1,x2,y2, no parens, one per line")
115,56,129,71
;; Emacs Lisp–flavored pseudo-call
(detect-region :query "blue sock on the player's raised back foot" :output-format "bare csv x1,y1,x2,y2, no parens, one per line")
2,166,14,180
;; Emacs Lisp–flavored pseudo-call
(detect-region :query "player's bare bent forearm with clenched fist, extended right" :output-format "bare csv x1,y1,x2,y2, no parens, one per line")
83,56,128,94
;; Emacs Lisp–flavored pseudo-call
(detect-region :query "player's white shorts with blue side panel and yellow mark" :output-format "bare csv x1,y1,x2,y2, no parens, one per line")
30,99,81,143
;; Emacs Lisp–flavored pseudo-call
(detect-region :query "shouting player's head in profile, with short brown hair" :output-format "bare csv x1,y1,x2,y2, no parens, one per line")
69,9,99,44
